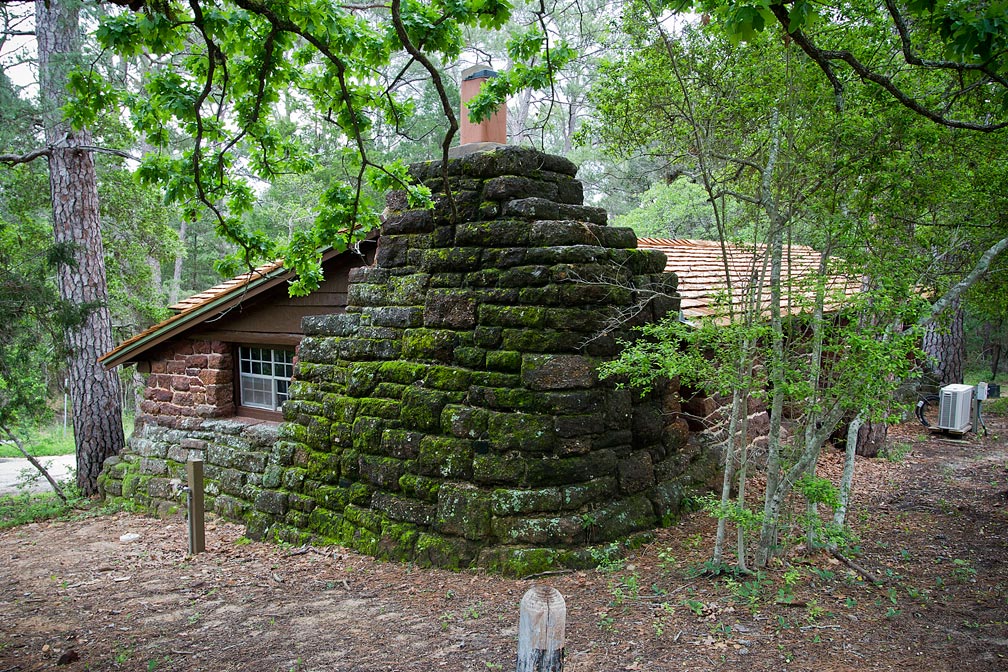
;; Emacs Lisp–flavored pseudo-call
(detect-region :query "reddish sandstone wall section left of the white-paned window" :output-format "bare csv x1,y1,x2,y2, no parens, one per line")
140,341,235,418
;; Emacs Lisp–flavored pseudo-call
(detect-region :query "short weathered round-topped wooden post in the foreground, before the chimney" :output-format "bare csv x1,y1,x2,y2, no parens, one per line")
516,585,566,672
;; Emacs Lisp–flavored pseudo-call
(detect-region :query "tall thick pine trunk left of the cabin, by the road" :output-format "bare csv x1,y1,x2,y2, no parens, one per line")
35,0,125,496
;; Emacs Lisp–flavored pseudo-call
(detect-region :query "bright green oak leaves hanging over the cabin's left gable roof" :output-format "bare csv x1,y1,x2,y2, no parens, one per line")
65,0,575,294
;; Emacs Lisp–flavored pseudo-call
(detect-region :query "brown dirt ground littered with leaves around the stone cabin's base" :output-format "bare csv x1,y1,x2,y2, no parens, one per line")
0,420,1008,672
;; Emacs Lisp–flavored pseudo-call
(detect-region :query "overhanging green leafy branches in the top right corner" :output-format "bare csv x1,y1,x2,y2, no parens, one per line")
677,0,1008,129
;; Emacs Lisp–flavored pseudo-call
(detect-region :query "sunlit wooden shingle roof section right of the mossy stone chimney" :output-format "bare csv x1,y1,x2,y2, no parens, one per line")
637,238,858,322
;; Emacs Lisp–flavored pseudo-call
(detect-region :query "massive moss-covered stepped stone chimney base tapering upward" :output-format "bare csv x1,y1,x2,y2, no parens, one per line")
247,147,712,573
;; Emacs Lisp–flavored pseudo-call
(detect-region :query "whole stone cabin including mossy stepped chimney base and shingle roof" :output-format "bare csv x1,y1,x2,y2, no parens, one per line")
100,145,858,575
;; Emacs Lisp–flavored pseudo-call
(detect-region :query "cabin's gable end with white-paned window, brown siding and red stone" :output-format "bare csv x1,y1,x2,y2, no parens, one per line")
101,238,376,425
